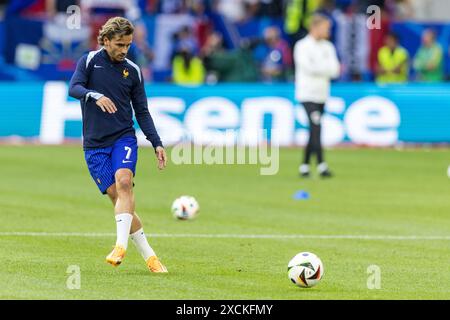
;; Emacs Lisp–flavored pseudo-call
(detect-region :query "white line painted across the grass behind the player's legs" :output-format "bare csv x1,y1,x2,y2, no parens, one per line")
0,232,450,241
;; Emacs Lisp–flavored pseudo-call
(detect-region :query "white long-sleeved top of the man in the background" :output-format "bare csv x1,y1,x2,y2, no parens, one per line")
294,35,340,103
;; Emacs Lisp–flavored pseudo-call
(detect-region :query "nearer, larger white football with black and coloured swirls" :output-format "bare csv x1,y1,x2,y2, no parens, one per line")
288,252,324,288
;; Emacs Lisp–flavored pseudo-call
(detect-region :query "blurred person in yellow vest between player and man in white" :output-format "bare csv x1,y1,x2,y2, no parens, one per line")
172,43,205,85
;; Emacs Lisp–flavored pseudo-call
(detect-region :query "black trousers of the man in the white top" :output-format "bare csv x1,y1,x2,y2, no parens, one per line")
303,102,325,164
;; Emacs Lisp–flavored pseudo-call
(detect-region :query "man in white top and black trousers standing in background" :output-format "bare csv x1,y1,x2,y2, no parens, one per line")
294,14,340,178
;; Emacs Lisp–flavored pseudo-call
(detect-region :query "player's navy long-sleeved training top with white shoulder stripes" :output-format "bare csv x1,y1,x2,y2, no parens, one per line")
69,49,162,150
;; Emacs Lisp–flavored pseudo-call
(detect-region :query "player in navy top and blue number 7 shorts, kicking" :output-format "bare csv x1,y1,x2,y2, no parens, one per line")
69,17,167,273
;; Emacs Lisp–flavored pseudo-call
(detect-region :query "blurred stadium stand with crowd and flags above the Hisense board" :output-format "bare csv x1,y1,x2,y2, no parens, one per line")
0,0,450,83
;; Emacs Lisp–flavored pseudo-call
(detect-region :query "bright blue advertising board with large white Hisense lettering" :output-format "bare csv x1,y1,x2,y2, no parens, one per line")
0,82,450,146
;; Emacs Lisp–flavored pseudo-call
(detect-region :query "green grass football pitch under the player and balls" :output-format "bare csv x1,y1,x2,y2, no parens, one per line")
0,146,450,300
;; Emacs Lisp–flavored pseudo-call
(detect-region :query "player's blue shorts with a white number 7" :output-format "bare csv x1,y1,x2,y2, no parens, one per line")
84,137,138,194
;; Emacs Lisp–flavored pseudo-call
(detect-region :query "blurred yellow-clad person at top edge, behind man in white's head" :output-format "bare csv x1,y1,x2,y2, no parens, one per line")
284,0,322,47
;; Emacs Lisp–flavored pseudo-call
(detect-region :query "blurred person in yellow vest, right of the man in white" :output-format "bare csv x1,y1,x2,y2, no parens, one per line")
376,33,409,83
